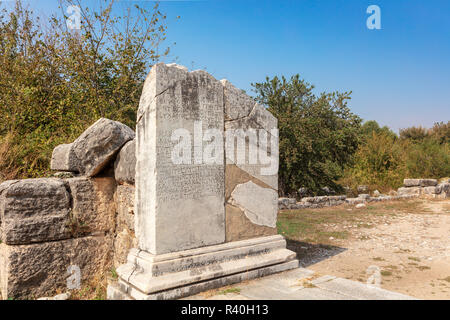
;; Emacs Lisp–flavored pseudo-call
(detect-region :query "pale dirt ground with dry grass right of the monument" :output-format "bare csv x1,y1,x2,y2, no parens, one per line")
278,199,450,299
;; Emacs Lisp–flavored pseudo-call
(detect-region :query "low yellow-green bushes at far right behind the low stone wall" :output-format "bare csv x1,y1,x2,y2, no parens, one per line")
339,122,450,191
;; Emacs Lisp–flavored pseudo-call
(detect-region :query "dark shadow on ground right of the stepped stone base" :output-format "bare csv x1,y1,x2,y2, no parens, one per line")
286,239,347,268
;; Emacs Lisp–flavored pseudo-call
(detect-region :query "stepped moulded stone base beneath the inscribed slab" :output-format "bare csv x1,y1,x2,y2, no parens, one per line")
108,235,298,300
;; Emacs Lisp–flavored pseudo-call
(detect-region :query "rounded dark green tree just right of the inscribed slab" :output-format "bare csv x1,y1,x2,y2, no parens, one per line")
252,74,361,195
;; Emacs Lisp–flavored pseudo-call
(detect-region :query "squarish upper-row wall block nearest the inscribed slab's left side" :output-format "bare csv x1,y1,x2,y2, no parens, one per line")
64,177,116,236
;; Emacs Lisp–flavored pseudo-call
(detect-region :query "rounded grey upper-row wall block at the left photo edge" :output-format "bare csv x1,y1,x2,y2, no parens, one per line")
0,178,70,244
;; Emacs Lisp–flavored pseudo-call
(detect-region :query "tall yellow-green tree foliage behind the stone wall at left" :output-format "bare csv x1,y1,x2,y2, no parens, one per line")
0,0,172,179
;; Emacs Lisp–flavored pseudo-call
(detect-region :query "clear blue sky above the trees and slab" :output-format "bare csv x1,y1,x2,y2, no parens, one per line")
12,0,450,131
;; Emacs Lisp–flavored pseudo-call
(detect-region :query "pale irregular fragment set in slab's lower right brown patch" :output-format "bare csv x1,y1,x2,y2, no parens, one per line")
230,181,278,228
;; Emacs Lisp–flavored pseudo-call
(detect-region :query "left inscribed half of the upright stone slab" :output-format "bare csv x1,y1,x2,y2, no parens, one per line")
135,64,225,254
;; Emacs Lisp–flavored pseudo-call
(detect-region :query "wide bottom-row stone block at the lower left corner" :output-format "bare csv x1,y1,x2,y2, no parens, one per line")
0,236,112,299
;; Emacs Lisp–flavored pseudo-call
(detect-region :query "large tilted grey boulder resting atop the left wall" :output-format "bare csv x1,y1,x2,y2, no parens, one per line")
72,118,134,177
